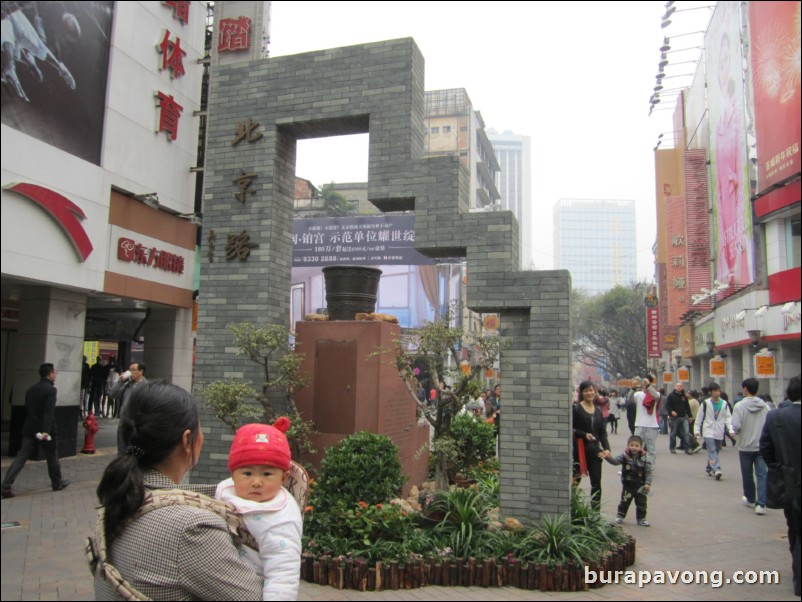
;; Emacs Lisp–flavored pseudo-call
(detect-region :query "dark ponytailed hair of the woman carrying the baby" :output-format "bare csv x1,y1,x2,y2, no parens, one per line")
97,381,200,543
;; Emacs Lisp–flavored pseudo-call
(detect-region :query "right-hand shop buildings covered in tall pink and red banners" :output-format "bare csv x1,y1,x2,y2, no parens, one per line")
655,2,802,402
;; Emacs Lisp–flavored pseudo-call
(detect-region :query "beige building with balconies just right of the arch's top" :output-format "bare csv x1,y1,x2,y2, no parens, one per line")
424,88,500,208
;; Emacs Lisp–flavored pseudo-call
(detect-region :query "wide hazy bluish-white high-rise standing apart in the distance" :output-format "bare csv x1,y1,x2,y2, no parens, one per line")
554,199,637,295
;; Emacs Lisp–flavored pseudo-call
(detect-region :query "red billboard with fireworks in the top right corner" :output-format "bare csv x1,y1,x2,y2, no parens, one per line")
749,2,802,192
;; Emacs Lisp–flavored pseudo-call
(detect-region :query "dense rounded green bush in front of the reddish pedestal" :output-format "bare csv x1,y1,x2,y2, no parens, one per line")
309,431,406,509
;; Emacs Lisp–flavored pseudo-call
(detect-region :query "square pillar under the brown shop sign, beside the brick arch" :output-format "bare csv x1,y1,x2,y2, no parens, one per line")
143,307,192,391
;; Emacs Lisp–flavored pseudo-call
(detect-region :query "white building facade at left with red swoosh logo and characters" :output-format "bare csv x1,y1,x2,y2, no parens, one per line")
0,2,207,455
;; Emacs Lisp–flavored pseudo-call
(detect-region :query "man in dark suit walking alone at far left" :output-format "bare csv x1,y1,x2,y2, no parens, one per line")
2,364,70,498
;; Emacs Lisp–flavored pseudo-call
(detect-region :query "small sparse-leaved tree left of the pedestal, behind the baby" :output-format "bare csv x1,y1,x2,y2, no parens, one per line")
202,322,315,461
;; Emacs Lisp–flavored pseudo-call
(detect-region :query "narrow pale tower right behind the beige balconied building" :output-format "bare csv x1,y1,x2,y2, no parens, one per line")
487,128,534,269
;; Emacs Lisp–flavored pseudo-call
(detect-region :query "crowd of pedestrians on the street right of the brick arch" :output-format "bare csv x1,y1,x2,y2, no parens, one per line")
573,374,802,596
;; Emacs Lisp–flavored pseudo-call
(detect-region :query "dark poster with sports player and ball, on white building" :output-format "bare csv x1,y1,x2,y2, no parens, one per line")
2,2,114,165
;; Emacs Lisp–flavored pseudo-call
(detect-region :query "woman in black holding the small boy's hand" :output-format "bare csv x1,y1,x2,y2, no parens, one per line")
573,380,610,510
